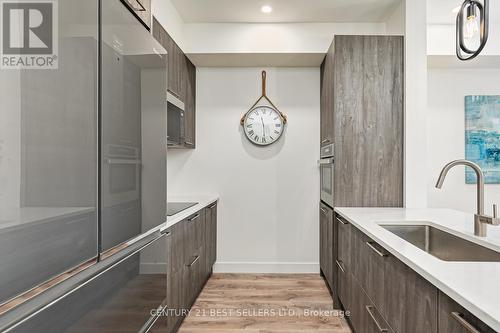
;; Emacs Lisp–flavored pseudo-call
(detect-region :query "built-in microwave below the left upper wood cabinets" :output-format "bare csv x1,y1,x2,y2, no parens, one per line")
167,92,185,147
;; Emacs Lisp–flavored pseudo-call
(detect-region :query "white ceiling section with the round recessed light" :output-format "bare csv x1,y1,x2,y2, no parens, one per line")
171,0,400,23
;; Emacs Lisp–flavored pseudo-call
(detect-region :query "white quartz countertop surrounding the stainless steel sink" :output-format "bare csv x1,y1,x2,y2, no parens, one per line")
335,208,500,332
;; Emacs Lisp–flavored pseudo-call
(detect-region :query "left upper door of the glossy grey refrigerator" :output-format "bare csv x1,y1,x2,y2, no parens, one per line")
0,0,98,303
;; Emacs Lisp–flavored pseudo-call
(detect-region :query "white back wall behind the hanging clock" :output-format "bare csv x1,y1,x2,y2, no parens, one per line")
168,68,320,272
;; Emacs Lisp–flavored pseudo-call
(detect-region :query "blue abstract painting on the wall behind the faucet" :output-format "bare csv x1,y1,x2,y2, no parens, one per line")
465,96,500,184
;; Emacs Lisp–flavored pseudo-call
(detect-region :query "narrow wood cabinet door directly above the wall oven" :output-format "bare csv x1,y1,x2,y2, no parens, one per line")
320,39,334,145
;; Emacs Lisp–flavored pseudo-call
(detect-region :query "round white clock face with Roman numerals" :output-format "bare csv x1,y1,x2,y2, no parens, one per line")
243,106,284,146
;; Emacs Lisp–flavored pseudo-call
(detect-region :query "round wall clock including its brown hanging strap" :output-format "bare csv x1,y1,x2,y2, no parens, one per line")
240,71,287,146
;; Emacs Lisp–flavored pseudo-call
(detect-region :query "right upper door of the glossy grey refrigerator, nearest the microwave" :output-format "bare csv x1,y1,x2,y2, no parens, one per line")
100,0,167,251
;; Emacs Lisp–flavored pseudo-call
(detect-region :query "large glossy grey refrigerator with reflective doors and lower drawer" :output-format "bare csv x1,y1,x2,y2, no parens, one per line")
0,0,168,332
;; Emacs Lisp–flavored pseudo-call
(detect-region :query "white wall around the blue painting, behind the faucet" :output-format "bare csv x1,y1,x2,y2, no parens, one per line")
427,69,500,213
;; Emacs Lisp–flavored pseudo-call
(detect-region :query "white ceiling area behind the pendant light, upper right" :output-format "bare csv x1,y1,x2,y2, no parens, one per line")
427,0,500,24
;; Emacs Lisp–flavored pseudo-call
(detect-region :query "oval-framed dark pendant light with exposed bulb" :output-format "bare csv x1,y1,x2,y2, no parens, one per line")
456,0,489,60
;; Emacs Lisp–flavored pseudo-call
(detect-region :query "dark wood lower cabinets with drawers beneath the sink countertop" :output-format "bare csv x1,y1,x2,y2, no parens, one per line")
334,216,495,333
